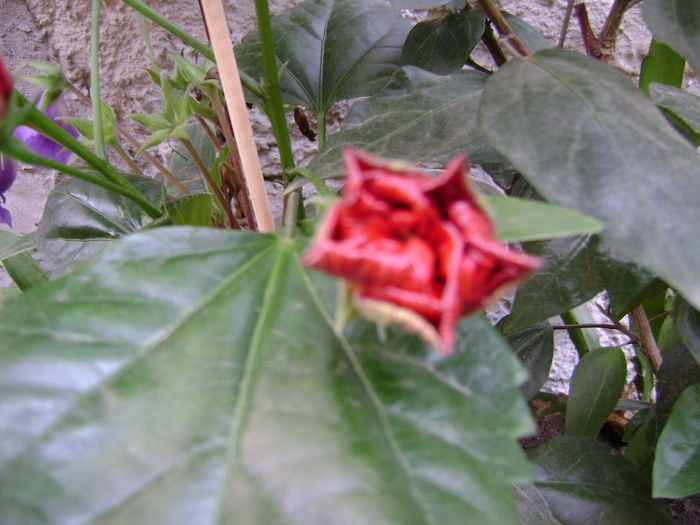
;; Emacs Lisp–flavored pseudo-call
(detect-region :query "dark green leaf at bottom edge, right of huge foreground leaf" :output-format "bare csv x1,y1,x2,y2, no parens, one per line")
529,436,673,525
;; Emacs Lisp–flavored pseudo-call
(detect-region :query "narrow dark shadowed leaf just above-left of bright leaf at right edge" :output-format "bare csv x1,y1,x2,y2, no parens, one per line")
625,343,700,475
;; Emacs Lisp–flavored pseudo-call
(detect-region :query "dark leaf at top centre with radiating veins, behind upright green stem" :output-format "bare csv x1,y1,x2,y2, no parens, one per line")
236,0,411,115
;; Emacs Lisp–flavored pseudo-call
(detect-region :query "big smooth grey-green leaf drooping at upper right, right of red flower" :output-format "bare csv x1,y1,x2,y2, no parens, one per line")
480,50,700,308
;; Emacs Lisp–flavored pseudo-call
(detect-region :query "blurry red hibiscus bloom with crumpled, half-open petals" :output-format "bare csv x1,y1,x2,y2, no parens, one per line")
303,148,540,354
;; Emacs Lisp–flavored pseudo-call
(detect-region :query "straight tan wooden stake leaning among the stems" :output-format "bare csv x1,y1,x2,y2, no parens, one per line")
201,0,275,233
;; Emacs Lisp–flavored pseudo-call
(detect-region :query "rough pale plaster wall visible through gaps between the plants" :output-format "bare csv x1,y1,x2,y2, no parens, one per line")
0,0,668,391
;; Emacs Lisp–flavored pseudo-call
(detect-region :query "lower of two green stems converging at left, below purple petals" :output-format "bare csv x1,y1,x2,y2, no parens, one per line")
2,137,163,219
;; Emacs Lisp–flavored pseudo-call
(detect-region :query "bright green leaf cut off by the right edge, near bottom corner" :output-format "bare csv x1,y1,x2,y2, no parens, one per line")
653,383,700,498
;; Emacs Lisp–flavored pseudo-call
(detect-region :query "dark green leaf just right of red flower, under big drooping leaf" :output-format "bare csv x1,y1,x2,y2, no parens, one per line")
505,236,603,332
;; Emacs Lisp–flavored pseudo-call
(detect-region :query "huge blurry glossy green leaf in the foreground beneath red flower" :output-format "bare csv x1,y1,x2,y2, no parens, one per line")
0,227,531,525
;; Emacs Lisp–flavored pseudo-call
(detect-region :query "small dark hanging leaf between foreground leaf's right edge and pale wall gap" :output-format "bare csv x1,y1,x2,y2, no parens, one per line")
501,321,554,399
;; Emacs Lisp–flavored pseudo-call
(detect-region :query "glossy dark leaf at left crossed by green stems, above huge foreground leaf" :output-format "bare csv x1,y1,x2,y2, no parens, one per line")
34,175,164,279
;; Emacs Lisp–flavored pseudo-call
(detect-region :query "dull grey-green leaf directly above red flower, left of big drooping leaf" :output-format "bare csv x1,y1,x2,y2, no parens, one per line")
309,66,488,178
